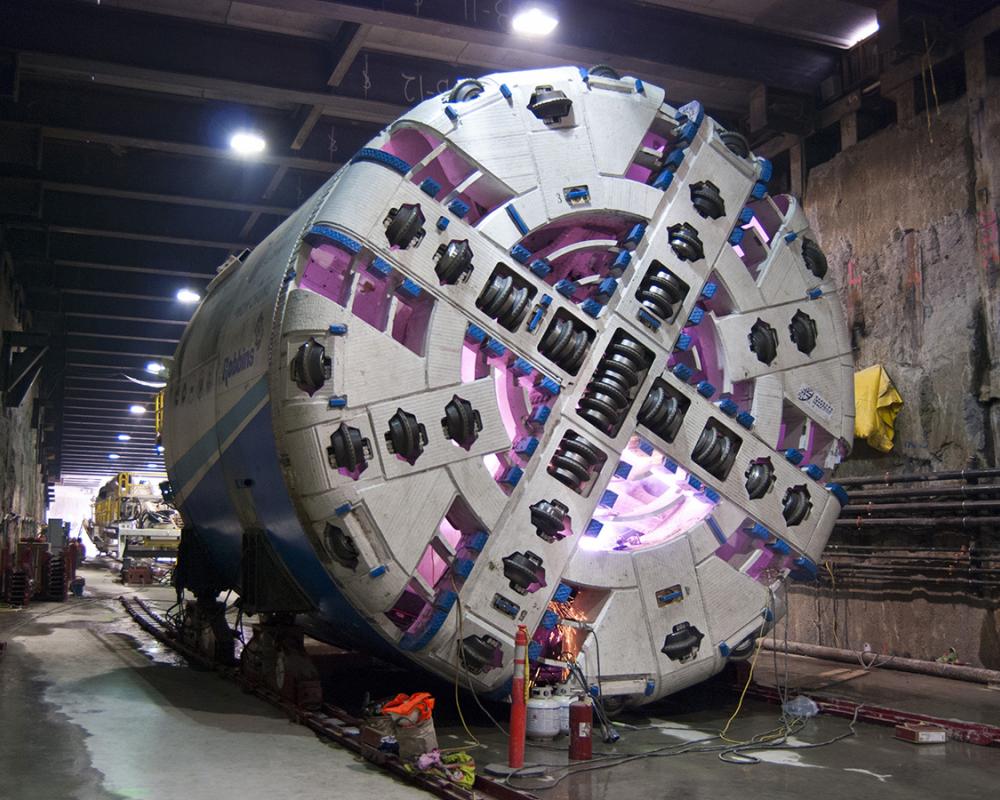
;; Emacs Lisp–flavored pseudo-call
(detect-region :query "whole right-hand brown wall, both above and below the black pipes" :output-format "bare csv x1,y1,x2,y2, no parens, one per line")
789,61,1000,668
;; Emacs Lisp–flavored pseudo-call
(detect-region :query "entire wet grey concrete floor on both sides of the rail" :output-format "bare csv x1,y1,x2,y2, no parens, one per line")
0,566,1000,800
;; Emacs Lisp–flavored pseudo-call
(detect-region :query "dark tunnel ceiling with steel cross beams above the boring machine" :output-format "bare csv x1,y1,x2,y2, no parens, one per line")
0,0,984,481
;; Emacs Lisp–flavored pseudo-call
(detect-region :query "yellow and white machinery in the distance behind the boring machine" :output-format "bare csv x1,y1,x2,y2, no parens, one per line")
94,472,181,559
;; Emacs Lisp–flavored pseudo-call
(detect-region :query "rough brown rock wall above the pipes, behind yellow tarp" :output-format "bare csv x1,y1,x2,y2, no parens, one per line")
805,82,1000,475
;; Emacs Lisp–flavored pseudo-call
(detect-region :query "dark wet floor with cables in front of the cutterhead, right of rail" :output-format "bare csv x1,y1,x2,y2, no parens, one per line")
453,684,1000,800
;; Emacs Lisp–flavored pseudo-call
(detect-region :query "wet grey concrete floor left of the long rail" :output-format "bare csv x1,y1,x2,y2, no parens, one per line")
0,568,422,800
